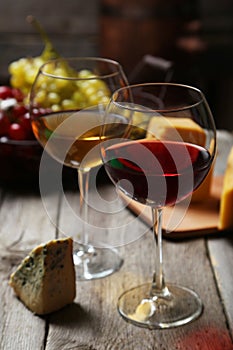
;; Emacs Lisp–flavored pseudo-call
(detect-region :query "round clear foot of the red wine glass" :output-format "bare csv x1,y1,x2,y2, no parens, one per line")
117,283,203,329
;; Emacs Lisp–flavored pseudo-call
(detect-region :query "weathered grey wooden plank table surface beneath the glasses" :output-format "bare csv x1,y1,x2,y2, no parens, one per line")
0,131,233,350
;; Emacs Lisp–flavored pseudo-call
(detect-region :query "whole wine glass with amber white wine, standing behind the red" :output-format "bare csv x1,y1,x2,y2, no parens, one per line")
30,57,127,280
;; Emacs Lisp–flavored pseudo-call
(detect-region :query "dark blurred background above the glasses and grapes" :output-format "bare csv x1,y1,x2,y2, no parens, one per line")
0,0,233,130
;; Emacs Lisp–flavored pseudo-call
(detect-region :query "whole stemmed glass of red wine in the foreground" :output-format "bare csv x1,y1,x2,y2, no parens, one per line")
100,83,216,329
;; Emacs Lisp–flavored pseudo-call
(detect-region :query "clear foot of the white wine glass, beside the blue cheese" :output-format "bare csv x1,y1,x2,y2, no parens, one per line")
73,246,123,281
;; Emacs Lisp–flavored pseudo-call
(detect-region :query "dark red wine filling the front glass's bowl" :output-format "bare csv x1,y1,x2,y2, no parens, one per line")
105,139,211,207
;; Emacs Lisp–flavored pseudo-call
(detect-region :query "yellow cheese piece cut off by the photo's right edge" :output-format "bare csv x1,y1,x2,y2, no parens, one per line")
218,147,233,230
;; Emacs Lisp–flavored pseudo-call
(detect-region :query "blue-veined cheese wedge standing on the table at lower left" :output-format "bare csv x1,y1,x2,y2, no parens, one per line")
9,238,76,315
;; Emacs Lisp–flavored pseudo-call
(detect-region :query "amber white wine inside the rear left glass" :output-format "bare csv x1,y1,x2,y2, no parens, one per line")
32,109,125,170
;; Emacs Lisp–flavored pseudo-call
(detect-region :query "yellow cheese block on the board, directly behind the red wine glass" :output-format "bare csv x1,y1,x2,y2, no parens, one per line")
147,116,214,202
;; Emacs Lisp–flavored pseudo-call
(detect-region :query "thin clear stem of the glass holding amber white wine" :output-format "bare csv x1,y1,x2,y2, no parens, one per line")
78,169,90,246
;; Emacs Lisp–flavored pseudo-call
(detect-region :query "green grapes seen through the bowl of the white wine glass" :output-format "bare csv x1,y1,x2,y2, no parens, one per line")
34,63,110,112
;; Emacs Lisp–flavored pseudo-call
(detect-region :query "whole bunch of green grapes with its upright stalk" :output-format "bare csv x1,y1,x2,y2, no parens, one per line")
8,16,110,111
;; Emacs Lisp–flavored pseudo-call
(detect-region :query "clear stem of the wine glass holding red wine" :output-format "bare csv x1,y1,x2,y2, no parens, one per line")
151,208,168,297
